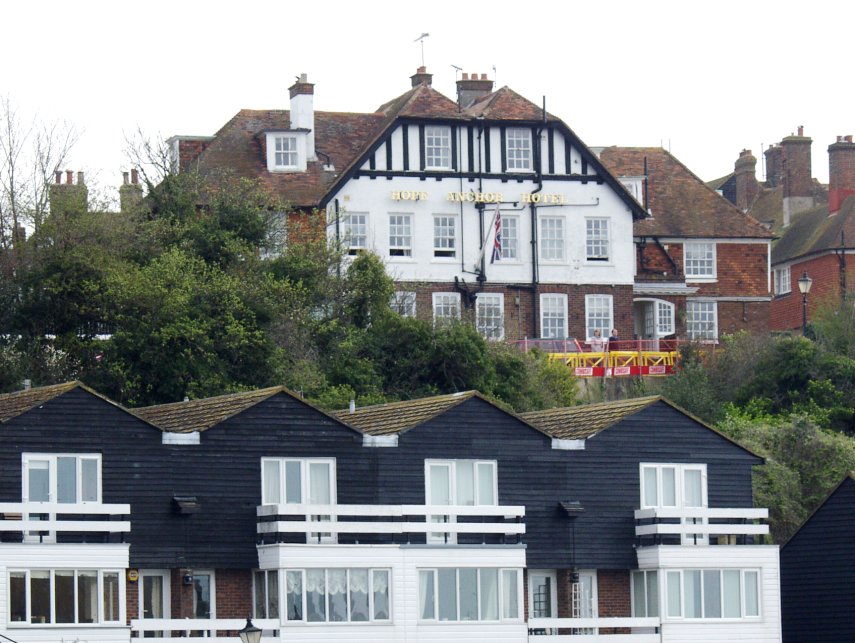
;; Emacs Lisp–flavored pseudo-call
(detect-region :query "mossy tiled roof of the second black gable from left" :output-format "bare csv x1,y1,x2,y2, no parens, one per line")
131,386,353,433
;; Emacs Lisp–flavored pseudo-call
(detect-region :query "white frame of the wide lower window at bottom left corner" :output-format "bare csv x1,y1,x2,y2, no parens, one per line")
4,566,127,629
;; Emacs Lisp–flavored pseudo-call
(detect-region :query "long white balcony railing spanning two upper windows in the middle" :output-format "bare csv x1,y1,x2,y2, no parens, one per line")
256,504,525,536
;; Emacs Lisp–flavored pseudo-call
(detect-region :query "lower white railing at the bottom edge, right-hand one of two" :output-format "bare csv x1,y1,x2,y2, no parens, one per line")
528,616,662,643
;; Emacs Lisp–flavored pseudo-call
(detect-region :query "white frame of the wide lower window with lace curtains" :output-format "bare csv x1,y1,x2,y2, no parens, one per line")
279,567,394,627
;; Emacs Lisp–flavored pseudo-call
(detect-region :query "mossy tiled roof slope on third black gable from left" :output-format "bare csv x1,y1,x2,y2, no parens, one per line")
333,391,480,435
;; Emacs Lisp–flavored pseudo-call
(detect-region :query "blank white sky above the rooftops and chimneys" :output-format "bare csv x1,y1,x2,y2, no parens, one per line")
0,0,855,204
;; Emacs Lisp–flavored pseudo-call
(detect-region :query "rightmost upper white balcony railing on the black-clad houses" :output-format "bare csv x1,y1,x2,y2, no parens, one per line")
635,507,769,544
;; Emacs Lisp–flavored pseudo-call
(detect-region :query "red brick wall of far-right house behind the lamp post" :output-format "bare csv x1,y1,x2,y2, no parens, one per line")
769,253,855,331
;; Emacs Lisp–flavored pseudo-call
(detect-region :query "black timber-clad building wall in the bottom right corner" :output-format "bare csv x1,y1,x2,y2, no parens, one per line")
781,476,855,643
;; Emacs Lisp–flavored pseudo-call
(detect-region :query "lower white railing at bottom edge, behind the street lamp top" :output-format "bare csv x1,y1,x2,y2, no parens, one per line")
131,618,280,643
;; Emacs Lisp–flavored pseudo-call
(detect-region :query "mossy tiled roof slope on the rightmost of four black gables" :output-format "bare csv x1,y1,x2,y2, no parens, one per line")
521,395,662,440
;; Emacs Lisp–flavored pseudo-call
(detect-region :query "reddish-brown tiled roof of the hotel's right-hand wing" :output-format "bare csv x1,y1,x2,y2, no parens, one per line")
600,147,772,239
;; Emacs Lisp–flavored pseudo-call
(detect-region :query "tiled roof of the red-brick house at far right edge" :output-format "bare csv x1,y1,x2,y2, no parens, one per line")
772,197,855,263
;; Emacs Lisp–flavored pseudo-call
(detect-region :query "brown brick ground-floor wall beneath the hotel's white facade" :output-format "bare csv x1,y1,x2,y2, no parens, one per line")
402,282,633,340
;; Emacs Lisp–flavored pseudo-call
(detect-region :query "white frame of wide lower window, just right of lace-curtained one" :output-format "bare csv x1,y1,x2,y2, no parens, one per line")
416,565,524,623
